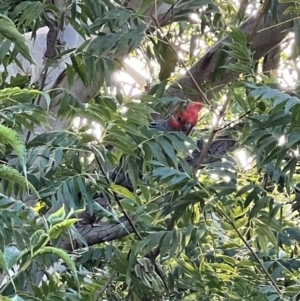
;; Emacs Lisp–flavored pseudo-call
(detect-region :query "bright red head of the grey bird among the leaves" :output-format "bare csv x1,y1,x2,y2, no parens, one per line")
169,102,203,135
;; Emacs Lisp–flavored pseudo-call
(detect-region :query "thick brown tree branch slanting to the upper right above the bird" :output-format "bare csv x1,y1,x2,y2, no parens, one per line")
167,4,293,101
